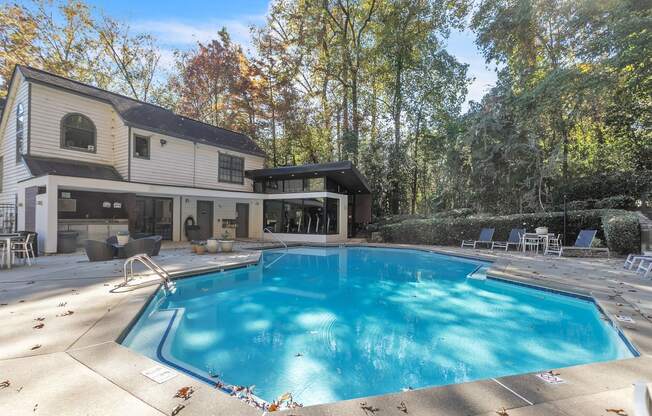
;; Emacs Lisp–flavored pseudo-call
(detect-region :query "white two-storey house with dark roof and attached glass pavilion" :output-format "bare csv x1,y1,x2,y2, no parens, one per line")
0,66,371,253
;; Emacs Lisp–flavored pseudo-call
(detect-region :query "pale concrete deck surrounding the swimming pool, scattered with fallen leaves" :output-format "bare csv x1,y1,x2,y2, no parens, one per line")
0,243,652,416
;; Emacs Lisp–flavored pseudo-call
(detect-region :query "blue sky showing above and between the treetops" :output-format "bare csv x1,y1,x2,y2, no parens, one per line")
89,0,496,106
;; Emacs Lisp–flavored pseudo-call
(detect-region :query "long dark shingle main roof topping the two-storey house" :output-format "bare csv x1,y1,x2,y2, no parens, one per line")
18,65,265,157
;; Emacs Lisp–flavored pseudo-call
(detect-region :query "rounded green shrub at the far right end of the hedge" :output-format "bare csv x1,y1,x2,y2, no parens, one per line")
602,211,641,254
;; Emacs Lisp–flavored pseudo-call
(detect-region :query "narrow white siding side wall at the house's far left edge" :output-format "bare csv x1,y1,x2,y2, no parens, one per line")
0,72,30,204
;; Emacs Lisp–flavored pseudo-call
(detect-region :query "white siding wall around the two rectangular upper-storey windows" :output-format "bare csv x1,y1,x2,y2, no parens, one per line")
125,128,264,192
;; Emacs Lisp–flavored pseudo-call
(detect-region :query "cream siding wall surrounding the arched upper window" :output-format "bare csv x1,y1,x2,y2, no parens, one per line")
31,84,122,165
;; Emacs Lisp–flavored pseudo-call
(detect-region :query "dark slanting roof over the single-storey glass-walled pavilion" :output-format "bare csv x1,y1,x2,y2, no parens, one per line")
245,160,371,194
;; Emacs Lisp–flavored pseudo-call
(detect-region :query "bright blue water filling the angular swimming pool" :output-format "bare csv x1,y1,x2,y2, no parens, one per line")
123,247,632,405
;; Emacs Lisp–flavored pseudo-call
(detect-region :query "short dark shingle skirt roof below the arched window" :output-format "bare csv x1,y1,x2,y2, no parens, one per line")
23,156,123,181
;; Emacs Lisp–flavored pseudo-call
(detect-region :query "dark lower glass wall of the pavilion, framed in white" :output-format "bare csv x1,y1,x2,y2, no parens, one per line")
263,198,339,234
